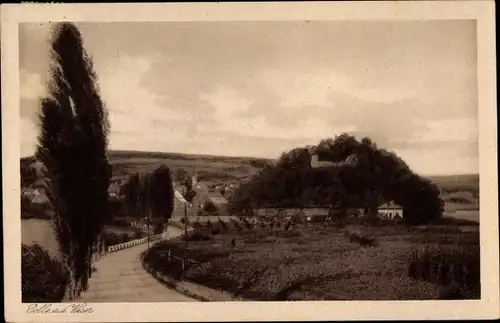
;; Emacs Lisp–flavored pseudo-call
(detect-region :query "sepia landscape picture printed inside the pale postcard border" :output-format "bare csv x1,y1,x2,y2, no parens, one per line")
2,4,498,320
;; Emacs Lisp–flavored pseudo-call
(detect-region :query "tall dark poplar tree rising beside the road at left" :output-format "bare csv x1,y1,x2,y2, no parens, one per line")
36,23,111,296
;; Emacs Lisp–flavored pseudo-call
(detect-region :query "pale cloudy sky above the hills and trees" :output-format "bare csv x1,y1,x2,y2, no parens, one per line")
19,20,479,175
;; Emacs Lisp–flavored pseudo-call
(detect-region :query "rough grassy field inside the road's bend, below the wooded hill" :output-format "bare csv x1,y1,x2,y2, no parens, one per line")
146,220,479,301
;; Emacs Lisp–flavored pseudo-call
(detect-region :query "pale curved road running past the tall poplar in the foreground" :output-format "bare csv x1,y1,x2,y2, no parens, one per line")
78,227,197,303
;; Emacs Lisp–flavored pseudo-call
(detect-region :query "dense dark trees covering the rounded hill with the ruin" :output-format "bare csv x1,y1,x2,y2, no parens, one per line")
229,134,443,223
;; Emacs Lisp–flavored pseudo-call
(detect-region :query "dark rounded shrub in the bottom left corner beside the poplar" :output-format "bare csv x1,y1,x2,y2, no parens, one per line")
21,244,69,303
